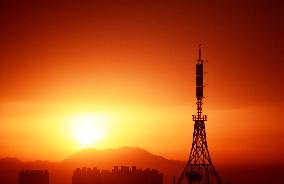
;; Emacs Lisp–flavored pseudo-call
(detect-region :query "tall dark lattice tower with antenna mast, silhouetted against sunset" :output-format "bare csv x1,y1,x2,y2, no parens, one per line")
177,48,222,184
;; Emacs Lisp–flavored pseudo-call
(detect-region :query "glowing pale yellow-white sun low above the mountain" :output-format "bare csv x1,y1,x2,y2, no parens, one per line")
71,114,106,147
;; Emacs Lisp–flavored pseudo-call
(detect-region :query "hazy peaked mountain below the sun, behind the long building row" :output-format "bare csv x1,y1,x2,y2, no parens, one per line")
62,147,185,183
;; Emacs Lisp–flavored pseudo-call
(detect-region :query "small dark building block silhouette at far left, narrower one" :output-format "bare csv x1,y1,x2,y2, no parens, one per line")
18,170,49,184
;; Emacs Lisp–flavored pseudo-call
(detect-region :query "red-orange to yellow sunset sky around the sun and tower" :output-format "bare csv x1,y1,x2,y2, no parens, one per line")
0,0,284,163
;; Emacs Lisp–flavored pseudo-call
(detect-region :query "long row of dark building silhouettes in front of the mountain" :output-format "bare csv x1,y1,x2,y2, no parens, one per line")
72,166,163,184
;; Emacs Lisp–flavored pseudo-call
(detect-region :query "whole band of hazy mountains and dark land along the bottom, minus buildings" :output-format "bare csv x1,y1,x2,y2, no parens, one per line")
0,147,284,184
